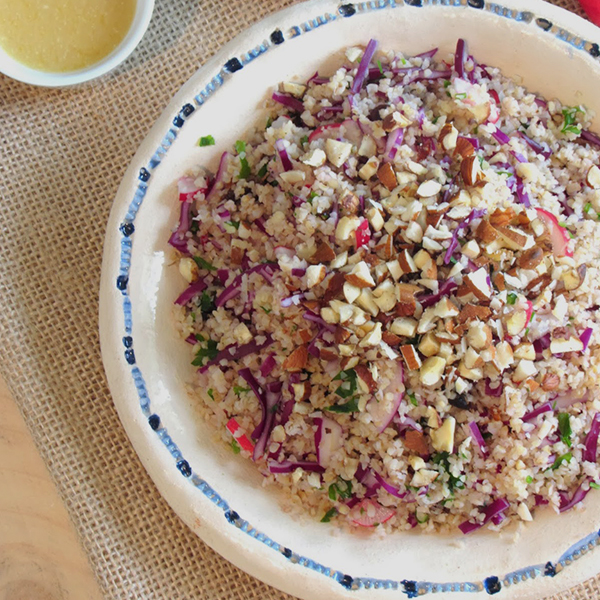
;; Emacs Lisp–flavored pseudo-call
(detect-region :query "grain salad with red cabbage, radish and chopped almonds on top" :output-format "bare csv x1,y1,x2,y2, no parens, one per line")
169,40,600,534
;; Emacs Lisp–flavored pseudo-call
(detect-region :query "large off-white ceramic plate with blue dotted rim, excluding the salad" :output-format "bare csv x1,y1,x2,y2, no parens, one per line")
100,0,600,600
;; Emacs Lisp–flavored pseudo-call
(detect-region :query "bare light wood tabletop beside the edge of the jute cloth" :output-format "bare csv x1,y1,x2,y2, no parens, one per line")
0,378,102,600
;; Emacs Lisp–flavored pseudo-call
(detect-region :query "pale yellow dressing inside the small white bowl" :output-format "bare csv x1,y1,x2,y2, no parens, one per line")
0,0,136,73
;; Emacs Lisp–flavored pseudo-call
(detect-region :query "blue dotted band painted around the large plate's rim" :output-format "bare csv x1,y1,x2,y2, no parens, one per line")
116,0,600,598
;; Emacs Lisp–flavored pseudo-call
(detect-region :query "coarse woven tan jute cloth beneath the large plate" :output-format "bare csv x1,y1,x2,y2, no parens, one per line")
0,0,600,600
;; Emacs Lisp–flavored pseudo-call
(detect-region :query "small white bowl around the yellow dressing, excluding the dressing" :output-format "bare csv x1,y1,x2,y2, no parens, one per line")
0,0,154,87
